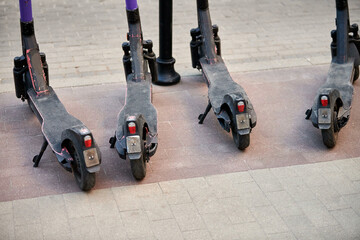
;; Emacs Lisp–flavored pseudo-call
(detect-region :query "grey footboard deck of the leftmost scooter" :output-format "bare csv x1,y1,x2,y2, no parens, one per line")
27,86,84,154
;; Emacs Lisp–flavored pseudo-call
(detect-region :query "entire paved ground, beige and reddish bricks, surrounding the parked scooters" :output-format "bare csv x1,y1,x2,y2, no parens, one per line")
0,0,360,240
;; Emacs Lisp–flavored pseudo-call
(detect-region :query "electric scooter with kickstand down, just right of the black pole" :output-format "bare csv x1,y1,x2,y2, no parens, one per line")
190,0,256,150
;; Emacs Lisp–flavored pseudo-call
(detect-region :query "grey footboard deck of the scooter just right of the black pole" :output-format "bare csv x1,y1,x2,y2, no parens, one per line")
200,56,256,119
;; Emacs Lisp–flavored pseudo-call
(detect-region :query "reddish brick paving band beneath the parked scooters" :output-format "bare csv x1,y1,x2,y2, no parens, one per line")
0,66,360,201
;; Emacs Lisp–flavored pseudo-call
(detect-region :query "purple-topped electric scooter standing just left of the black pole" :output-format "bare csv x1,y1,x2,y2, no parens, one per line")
109,0,158,180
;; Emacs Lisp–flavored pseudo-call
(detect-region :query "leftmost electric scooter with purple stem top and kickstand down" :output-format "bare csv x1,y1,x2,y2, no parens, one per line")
13,0,101,191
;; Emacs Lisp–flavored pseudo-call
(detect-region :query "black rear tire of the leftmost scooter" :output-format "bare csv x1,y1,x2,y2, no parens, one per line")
67,143,95,191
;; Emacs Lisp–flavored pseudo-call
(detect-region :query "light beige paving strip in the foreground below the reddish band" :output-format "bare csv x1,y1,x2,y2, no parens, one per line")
0,158,360,240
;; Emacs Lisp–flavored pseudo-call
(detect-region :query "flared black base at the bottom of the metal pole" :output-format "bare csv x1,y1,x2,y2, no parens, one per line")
153,58,180,86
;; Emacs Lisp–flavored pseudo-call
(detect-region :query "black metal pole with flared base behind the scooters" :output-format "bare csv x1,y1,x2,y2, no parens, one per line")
154,0,180,85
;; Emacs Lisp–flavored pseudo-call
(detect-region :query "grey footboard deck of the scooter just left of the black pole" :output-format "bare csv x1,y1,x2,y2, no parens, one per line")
116,73,157,140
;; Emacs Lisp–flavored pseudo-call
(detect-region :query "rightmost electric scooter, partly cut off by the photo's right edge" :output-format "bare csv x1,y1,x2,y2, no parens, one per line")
306,0,360,148
